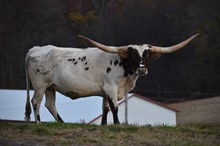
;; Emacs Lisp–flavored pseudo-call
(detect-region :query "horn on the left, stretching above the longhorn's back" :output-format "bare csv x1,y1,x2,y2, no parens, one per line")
78,35,121,53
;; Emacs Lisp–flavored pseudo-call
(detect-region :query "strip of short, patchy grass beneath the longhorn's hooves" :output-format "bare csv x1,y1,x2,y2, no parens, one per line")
0,122,220,146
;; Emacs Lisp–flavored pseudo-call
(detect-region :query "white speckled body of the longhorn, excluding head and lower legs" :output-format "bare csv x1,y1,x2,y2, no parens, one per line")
26,45,137,100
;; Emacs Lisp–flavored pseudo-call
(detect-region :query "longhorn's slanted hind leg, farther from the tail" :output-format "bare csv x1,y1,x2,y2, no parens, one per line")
45,87,63,122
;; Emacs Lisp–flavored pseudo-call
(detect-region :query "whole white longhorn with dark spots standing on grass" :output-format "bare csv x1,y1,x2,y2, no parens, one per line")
25,34,198,124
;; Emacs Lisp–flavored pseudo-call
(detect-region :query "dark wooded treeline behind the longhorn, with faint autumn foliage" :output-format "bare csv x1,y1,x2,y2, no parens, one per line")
0,0,220,101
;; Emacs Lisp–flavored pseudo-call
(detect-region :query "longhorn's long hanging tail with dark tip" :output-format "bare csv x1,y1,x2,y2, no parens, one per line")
25,63,31,121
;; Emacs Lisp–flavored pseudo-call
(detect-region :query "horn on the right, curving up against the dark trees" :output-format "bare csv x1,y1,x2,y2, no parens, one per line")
150,33,199,53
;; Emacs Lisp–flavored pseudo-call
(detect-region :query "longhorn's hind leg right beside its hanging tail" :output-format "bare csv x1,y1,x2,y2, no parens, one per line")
31,88,45,123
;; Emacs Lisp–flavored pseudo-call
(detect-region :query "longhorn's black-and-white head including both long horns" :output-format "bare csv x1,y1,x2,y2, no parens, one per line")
79,34,198,75
